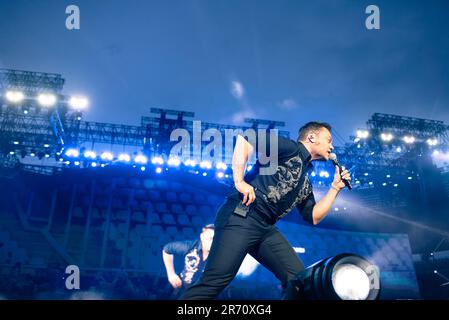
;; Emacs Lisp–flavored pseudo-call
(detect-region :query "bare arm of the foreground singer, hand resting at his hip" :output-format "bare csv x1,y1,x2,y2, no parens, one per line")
232,135,256,206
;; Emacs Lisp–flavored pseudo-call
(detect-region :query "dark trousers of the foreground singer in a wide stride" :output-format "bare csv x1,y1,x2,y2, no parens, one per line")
180,199,304,300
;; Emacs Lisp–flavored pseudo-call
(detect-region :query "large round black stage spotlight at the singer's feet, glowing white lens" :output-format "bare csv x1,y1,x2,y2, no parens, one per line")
285,253,380,300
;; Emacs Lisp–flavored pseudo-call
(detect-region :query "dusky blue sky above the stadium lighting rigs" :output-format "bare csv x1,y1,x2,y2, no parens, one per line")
0,0,449,145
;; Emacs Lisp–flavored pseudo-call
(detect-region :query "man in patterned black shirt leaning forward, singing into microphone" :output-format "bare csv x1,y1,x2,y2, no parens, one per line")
181,122,351,300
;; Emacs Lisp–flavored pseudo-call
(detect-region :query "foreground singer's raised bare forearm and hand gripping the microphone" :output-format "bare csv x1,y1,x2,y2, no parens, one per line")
312,167,351,225
